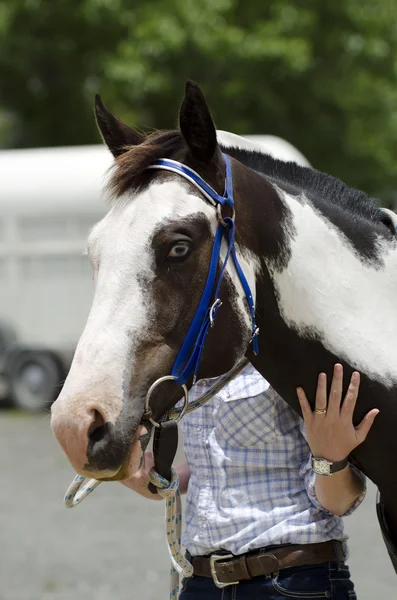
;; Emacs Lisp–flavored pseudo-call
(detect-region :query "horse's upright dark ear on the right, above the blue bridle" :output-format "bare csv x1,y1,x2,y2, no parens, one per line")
179,81,218,163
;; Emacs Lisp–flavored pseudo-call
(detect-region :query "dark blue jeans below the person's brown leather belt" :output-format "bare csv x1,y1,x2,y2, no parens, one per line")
180,563,357,600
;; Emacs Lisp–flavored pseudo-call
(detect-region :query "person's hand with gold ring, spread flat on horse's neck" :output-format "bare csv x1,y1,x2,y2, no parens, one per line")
296,364,379,462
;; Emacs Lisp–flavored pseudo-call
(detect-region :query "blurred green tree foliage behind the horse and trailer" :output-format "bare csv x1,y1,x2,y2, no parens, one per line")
0,0,397,195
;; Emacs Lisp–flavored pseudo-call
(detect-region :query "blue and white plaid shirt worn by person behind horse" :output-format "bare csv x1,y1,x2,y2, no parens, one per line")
181,365,365,557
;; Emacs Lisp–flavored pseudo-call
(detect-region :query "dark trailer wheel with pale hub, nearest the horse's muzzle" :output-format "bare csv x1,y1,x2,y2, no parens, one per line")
8,350,64,412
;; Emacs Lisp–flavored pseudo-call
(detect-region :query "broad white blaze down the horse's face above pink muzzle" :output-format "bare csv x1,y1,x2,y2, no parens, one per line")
56,181,215,412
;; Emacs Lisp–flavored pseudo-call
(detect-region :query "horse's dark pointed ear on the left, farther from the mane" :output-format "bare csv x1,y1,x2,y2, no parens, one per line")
95,94,143,158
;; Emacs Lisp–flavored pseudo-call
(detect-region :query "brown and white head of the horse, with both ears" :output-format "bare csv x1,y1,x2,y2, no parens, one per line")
52,84,259,479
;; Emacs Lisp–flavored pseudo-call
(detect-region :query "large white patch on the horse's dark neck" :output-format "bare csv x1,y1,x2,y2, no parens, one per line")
268,190,397,386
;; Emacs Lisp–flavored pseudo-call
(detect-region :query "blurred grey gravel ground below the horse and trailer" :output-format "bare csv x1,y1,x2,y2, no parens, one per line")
0,411,397,600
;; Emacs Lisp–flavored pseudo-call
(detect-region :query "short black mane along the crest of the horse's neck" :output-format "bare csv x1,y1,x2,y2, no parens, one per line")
223,147,390,225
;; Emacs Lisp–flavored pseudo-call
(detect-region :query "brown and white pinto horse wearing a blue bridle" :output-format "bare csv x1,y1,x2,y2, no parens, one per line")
51,82,397,570
